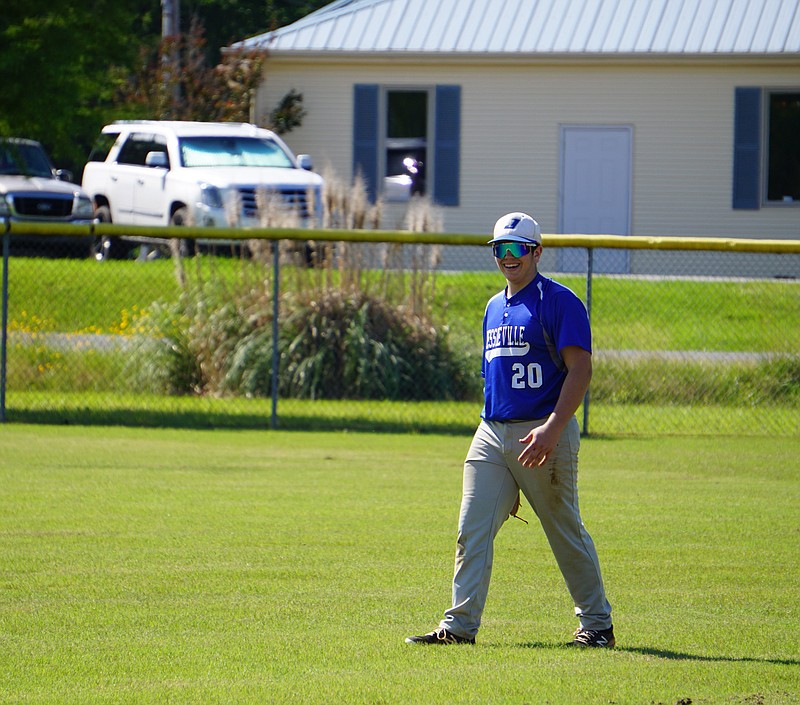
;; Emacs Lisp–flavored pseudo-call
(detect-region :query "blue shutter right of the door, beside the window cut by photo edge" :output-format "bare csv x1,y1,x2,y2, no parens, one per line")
733,88,761,210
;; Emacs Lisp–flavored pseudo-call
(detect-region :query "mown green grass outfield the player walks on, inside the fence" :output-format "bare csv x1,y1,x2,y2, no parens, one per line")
0,424,800,705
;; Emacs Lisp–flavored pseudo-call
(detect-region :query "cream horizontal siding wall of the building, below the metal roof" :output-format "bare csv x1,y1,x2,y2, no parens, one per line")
258,57,800,248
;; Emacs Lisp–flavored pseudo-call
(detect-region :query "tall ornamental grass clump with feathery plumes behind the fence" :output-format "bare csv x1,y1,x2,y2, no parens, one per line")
131,170,479,400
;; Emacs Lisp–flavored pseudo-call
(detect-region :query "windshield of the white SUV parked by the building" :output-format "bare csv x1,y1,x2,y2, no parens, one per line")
180,137,294,169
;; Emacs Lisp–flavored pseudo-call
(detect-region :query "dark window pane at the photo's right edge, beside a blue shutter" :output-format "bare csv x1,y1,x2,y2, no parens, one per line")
767,93,800,201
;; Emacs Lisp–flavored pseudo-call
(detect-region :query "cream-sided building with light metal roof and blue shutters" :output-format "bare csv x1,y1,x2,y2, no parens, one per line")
242,0,800,271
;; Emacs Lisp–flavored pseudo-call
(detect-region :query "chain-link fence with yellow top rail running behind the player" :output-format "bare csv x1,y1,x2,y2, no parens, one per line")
0,228,800,435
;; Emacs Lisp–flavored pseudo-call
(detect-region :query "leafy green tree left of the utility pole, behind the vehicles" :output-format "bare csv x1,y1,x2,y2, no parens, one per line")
0,0,160,170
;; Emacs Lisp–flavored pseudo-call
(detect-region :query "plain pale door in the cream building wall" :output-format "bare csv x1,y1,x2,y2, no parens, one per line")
557,125,633,274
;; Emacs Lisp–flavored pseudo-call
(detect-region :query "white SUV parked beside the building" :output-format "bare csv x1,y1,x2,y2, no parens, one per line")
82,120,322,256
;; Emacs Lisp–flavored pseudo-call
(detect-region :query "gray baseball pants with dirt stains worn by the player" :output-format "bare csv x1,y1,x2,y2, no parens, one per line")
439,417,611,637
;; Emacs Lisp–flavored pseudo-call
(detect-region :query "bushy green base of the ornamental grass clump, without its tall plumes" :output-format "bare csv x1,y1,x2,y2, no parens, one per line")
128,262,474,400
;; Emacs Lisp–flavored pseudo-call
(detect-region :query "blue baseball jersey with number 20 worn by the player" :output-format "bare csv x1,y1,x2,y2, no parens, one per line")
481,273,592,421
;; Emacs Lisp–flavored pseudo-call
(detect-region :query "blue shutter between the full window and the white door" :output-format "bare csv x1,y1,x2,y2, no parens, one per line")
432,86,461,206
